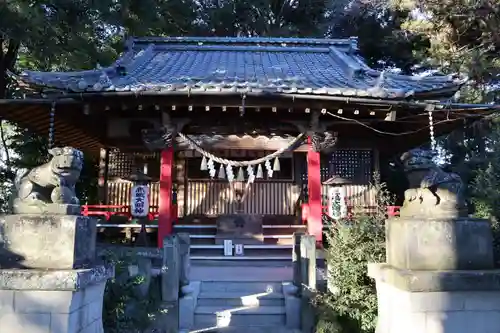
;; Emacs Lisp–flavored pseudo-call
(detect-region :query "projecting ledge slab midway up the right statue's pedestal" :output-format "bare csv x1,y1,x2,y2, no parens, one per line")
368,264,500,292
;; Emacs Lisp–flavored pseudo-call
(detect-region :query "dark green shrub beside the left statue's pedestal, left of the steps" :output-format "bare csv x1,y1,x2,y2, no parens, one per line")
103,252,161,333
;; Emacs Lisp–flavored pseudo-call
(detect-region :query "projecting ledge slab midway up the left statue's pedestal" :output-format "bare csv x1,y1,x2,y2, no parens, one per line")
0,265,114,291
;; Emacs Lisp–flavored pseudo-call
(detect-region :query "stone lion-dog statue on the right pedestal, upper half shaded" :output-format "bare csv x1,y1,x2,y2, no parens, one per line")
400,148,467,218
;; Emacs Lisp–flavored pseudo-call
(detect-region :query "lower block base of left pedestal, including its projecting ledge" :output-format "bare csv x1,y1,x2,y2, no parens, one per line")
0,267,113,333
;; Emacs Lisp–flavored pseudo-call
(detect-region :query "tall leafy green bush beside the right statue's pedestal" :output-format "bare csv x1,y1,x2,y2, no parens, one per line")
316,177,391,333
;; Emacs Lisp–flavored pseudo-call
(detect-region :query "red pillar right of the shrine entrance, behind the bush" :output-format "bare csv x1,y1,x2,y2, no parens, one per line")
307,137,323,244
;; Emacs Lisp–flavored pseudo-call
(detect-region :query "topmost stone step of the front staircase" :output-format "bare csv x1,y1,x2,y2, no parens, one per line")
200,281,283,295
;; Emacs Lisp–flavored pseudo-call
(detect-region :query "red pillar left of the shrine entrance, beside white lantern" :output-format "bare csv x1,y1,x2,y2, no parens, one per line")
158,147,174,248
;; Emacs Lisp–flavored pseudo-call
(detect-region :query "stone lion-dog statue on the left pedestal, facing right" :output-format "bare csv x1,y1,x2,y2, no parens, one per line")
13,147,83,214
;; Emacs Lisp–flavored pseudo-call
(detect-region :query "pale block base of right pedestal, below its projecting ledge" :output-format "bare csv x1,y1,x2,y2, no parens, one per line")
376,266,500,333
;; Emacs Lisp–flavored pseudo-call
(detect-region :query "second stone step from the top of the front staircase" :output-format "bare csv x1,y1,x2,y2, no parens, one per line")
197,291,285,306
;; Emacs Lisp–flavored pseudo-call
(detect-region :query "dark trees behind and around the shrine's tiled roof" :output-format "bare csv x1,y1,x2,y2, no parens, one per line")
0,0,500,211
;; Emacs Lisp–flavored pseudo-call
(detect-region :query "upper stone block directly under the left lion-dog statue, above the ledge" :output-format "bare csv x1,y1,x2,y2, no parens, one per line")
0,214,97,269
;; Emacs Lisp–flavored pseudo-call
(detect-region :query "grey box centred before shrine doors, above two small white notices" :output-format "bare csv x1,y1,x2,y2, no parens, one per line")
215,214,264,245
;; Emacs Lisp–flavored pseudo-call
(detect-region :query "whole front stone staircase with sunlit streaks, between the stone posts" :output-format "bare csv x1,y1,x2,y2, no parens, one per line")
189,281,300,333
